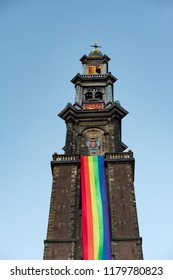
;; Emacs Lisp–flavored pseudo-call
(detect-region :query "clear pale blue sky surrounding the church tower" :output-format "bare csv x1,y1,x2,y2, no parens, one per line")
0,0,173,260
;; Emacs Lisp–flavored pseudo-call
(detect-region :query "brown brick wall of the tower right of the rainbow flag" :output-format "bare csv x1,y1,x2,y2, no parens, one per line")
107,160,142,259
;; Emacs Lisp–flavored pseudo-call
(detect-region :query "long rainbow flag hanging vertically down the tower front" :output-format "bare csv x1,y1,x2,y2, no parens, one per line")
81,156,111,260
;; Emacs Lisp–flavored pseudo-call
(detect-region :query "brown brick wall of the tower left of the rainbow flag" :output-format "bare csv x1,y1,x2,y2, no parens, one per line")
44,162,80,259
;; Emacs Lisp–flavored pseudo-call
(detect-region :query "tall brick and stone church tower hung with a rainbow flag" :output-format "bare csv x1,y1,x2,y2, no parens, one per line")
44,44,143,260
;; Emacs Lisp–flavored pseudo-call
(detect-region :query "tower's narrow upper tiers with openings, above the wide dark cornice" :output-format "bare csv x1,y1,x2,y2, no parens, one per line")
72,44,117,109
